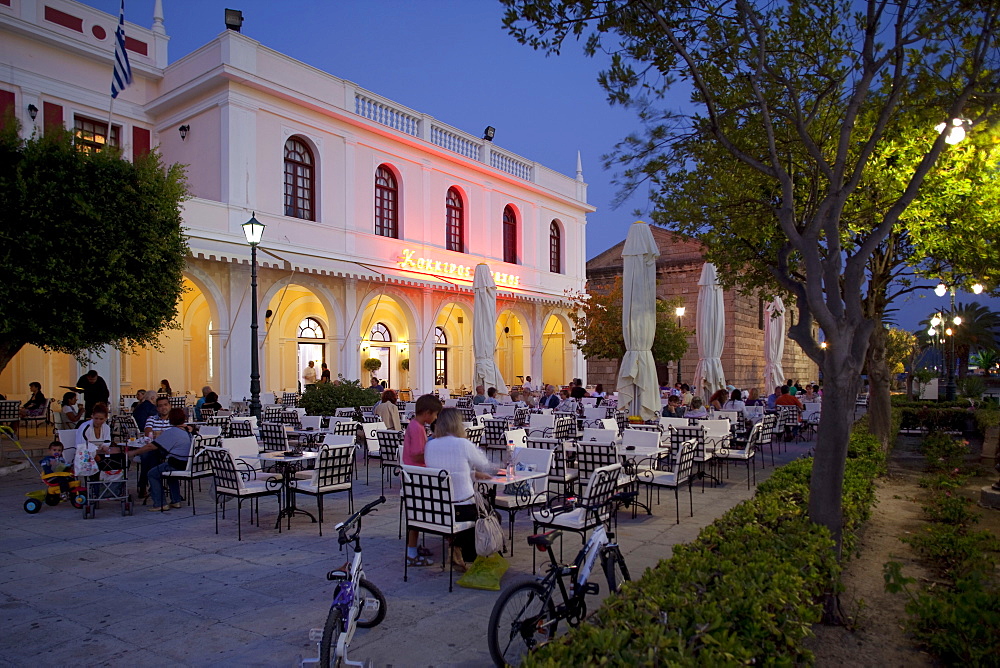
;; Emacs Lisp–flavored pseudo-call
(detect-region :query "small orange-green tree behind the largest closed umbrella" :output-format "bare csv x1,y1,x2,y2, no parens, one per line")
567,276,688,365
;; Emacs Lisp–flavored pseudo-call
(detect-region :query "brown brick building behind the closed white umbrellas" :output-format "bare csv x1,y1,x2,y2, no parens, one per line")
587,225,819,396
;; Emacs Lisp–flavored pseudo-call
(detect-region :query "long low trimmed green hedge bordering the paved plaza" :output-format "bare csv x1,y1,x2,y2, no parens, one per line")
527,411,899,666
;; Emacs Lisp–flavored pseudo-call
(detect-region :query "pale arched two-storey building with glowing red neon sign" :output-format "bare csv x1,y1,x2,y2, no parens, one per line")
0,0,593,408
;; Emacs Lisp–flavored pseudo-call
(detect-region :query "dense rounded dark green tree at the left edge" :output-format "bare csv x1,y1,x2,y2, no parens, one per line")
0,123,187,371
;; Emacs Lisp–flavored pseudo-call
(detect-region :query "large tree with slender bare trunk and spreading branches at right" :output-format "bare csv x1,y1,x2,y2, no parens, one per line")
503,0,1000,617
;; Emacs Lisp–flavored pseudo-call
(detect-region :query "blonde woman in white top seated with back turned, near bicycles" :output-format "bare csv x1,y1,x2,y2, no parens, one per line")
424,408,496,570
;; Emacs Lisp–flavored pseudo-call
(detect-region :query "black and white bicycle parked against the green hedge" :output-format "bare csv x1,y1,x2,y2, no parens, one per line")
487,526,632,667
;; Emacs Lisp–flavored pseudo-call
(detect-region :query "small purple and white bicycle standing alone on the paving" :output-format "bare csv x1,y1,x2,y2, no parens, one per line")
302,496,386,668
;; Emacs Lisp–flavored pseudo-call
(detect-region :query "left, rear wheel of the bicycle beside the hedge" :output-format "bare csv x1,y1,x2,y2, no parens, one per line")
486,582,558,668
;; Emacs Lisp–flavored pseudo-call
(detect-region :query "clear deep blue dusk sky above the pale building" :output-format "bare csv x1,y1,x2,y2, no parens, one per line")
76,0,997,329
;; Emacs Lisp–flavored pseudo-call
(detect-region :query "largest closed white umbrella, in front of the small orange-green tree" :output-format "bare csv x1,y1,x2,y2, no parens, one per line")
618,226,660,420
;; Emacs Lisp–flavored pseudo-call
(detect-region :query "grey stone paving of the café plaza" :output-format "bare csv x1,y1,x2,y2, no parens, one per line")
0,438,812,666
